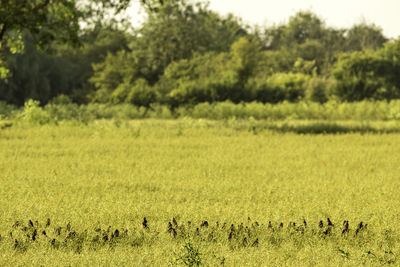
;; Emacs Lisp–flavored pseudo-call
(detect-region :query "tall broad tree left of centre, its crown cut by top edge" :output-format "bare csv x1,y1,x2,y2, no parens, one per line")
131,0,247,84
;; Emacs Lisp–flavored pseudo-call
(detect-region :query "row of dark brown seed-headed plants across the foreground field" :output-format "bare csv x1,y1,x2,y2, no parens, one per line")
0,217,368,252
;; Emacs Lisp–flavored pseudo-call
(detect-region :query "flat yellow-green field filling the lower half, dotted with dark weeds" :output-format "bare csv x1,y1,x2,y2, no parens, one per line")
0,120,400,266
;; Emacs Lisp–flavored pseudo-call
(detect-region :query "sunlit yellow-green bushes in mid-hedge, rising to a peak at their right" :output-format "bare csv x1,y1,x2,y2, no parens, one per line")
161,38,260,106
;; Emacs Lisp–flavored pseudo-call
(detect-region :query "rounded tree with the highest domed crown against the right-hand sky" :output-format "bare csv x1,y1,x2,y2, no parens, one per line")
264,11,345,74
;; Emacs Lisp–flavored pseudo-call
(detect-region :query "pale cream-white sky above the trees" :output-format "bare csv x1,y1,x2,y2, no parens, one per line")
130,0,400,38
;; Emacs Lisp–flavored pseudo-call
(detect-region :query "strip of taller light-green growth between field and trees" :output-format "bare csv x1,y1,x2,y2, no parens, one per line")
0,100,400,122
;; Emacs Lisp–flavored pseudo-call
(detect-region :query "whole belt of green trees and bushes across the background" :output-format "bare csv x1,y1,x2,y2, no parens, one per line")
0,0,400,108
